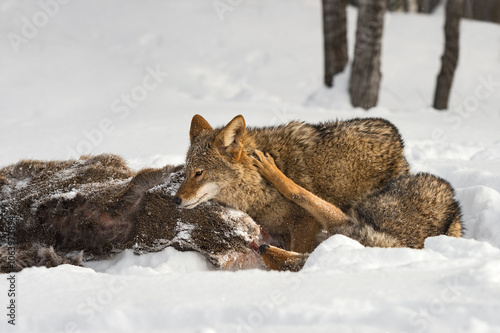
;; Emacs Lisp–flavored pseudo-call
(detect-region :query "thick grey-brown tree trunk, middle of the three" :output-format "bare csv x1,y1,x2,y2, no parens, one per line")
349,0,386,110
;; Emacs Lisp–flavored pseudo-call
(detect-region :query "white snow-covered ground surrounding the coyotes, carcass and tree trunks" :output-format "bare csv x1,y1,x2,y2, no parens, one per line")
0,0,500,333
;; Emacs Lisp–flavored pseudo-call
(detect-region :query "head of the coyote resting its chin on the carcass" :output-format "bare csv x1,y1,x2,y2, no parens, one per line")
173,115,257,208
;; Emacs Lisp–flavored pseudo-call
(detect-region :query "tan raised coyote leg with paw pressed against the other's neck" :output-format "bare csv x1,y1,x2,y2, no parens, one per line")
254,150,348,230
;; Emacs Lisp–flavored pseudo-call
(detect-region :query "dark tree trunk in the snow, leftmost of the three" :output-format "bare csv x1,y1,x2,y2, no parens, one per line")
322,0,348,87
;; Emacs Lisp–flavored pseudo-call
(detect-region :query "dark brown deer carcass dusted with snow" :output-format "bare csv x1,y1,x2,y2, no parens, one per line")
0,155,270,273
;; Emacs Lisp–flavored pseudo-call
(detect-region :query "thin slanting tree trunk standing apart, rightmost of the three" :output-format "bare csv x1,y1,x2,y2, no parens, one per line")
434,0,464,110
